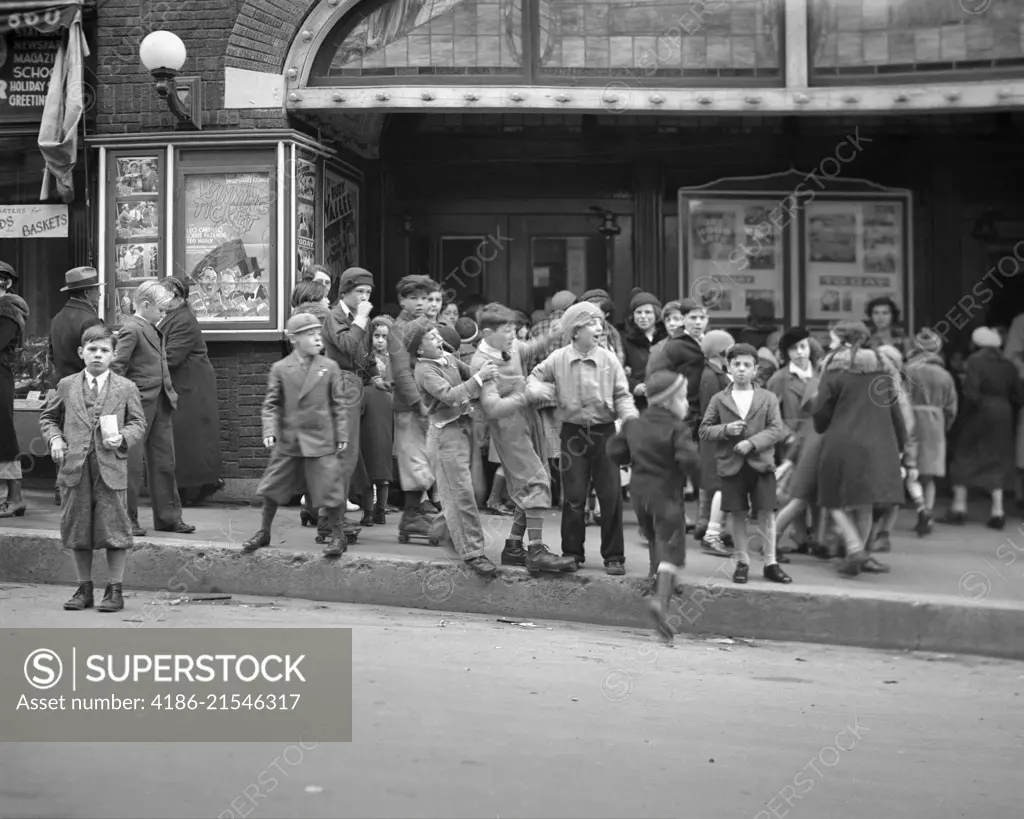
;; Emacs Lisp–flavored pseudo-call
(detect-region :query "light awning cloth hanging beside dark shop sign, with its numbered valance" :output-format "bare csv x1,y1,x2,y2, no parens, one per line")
0,0,89,203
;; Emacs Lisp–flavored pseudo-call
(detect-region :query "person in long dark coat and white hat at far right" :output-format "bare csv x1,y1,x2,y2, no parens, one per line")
943,327,1024,529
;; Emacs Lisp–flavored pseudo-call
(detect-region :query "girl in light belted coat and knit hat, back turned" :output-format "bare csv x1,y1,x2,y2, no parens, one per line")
906,329,956,535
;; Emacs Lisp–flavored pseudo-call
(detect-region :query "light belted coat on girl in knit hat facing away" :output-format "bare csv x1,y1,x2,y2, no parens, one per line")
904,353,956,478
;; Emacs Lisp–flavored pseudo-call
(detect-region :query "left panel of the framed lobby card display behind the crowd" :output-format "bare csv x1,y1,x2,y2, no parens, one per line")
679,197,785,320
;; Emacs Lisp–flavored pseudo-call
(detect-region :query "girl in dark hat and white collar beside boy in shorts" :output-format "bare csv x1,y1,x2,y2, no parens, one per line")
767,327,820,562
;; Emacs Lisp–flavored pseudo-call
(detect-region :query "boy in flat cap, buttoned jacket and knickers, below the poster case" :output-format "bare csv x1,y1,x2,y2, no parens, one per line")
242,313,359,557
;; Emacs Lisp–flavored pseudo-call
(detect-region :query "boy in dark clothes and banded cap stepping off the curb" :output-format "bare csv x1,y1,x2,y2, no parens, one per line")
608,370,699,642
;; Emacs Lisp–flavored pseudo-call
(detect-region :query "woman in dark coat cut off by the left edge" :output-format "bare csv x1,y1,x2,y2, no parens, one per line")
0,262,29,518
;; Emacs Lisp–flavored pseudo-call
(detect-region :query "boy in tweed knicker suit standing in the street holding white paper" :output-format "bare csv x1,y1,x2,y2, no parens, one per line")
39,325,145,611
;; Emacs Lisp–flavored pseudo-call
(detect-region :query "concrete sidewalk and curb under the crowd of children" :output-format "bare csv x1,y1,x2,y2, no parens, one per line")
0,491,1024,658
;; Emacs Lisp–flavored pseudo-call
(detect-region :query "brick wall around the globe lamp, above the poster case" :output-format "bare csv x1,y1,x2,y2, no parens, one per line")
92,0,292,134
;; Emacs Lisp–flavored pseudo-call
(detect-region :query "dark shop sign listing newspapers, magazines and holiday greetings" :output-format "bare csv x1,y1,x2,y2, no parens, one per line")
0,2,81,121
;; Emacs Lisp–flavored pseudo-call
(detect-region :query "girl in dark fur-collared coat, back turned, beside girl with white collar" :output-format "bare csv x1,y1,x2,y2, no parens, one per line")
812,321,906,576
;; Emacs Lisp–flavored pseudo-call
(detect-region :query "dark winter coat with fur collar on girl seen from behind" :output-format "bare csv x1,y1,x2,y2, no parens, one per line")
812,348,907,509
